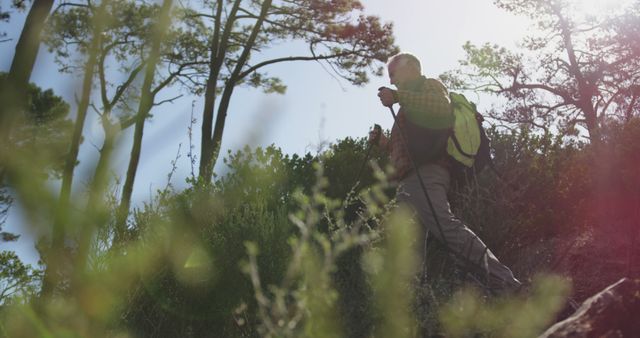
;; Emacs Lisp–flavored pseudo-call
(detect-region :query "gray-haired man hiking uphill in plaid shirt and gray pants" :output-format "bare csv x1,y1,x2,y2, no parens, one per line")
369,53,521,291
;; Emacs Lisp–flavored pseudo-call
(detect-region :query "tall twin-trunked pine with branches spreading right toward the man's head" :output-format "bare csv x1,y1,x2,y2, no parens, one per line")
192,0,397,181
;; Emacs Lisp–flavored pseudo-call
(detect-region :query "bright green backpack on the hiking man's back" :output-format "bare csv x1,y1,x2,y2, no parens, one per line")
447,92,491,174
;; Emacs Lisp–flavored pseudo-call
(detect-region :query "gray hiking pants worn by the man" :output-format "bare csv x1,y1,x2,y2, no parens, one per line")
397,164,521,289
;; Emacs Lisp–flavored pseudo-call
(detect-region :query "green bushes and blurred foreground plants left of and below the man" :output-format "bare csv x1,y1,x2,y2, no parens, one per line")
1,141,584,337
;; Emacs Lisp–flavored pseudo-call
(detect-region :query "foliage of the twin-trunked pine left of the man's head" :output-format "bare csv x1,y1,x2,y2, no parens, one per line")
200,0,397,88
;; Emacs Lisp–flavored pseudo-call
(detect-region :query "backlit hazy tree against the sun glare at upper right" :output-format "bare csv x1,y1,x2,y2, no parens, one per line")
444,0,640,143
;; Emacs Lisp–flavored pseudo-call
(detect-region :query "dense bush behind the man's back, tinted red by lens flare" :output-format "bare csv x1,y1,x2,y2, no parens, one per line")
452,119,640,297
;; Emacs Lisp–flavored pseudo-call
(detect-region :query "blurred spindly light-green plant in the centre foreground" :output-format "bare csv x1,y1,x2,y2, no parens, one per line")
244,165,398,337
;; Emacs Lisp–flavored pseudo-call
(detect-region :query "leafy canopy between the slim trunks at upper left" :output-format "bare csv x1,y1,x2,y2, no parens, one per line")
43,0,206,119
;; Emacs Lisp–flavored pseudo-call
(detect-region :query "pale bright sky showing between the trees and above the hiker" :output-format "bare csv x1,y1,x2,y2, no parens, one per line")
0,0,529,264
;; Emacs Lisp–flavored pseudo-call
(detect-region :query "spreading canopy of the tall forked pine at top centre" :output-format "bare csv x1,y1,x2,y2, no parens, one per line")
181,0,397,93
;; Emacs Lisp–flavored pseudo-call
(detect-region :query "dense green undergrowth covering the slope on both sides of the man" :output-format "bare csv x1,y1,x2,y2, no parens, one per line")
0,120,640,337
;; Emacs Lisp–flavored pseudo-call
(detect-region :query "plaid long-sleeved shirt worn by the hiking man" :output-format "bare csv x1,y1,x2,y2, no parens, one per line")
380,76,453,181
